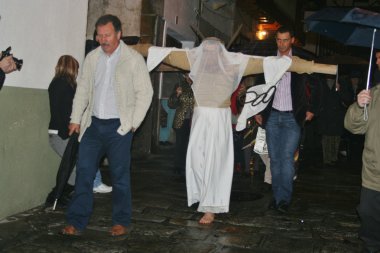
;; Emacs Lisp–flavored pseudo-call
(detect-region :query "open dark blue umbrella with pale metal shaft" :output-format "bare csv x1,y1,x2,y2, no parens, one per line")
305,8,380,89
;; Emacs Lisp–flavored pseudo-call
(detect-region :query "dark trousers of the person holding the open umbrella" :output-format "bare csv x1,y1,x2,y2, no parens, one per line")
357,187,380,252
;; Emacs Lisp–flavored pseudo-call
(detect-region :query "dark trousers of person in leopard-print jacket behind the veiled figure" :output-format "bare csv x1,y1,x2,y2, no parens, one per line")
175,119,191,176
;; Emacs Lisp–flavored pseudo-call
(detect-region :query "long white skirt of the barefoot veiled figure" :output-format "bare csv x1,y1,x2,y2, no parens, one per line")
186,107,234,213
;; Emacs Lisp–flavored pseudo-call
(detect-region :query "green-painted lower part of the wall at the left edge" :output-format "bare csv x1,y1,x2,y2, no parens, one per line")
0,87,59,219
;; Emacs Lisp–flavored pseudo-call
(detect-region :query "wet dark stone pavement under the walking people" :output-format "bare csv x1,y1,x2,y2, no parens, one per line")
0,147,361,253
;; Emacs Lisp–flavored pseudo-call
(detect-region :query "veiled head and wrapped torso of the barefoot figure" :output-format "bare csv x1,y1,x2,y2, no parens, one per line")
187,38,249,107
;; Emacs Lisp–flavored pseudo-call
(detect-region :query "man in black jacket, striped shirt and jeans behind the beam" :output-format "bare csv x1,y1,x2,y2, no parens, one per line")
256,26,318,213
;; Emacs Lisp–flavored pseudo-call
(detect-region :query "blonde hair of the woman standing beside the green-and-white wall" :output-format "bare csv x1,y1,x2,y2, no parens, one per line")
54,55,79,88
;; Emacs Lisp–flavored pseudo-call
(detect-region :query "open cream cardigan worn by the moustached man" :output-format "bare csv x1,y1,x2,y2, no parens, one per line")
71,41,153,140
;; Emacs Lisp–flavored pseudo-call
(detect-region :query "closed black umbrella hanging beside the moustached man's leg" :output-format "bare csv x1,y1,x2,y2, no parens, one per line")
53,132,79,210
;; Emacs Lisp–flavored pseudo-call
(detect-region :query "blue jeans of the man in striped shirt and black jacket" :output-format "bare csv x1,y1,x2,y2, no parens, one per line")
265,110,301,204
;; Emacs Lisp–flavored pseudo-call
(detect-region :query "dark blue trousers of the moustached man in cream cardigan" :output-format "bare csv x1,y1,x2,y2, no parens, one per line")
67,117,133,230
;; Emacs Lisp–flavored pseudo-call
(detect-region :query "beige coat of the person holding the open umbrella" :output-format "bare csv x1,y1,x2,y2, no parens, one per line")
344,85,380,192
